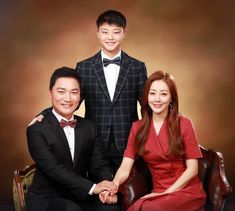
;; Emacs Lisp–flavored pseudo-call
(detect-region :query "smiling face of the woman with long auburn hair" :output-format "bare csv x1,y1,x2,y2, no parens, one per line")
148,80,171,116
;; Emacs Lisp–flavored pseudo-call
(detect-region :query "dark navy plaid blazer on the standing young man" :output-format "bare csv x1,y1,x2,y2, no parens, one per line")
76,51,147,155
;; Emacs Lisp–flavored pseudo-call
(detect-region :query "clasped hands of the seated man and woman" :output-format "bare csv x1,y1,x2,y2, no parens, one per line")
93,180,118,204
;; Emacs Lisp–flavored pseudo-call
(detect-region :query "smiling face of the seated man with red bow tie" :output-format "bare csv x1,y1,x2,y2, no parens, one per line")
49,77,80,119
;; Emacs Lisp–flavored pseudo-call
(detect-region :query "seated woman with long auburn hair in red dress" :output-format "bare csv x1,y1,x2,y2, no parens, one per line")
113,71,206,211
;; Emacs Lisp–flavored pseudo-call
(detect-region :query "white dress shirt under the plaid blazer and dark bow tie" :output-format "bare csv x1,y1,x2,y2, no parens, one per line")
101,50,121,101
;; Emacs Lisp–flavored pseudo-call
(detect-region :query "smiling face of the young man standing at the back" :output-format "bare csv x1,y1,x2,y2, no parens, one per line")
97,23,126,57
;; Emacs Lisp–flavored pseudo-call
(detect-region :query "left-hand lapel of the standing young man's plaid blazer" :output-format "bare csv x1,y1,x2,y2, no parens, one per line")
93,52,111,102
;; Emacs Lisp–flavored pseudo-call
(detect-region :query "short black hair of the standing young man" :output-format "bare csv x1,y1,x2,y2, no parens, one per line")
96,10,127,29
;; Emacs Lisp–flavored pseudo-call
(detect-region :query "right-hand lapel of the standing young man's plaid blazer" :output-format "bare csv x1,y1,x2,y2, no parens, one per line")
112,51,131,103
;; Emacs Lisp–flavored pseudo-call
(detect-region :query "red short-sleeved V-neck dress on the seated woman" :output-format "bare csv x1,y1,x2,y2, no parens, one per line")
124,116,206,211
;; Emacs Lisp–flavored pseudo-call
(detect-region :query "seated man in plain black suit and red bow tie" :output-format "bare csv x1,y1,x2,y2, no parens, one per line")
26,67,119,211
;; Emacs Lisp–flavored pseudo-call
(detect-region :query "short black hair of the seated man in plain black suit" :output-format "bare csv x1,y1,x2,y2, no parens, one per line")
49,67,80,90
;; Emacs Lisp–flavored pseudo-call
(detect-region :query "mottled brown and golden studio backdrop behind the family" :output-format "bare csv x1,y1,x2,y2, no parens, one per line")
0,0,235,204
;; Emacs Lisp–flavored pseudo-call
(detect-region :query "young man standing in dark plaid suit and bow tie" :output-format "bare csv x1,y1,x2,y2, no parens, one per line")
76,10,147,174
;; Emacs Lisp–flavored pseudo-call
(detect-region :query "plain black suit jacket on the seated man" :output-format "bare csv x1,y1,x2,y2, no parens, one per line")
27,111,111,200
